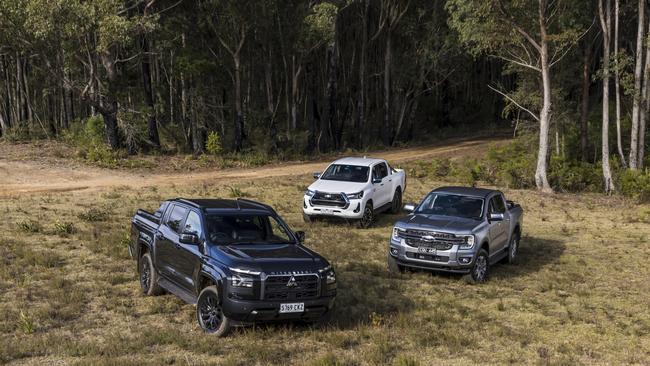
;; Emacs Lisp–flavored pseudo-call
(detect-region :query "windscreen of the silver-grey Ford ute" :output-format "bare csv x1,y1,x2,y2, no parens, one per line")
416,193,483,219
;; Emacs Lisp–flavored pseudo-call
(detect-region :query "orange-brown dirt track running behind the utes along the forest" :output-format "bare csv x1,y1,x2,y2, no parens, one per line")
0,138,506,198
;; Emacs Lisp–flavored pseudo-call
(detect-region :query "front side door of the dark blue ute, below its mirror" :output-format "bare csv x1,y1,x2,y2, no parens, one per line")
175,210,205,291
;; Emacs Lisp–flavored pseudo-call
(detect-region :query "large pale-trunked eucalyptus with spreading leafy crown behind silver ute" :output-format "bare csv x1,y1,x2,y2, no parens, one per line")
447,0,584,192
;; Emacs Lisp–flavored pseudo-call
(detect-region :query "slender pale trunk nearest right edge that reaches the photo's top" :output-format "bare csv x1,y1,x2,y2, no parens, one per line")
628,0,646,169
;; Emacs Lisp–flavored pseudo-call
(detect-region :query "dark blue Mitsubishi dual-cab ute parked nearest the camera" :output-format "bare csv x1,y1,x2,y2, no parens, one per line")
129,199,337,336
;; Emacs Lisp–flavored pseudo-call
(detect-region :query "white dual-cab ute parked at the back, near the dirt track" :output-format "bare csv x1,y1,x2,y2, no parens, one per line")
302,157,406,228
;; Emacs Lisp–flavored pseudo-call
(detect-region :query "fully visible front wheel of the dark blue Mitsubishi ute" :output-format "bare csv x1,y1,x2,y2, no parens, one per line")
196,286,231,337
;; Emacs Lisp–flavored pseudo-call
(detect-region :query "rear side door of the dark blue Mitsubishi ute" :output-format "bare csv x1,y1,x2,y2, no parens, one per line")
155,204,188,284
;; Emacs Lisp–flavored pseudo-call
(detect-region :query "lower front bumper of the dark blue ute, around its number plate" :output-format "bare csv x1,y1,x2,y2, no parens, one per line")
222,295,336,323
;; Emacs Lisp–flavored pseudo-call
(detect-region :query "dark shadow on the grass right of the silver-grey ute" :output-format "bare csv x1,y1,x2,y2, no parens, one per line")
490,235,566,279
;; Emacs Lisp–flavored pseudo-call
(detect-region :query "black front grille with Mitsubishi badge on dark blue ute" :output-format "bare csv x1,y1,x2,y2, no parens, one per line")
263,274,319,300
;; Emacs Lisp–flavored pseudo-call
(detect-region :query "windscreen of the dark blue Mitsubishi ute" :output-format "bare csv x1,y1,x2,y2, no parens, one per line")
205,214,294,245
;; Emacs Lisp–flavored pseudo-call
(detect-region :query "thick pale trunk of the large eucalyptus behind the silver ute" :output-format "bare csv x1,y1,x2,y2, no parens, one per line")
535,0,553,192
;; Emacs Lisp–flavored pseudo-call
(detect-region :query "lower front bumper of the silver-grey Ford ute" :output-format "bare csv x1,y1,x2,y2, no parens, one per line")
388,238,476,274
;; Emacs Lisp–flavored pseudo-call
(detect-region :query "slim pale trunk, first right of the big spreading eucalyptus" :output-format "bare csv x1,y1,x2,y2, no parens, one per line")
598,0,612,194
